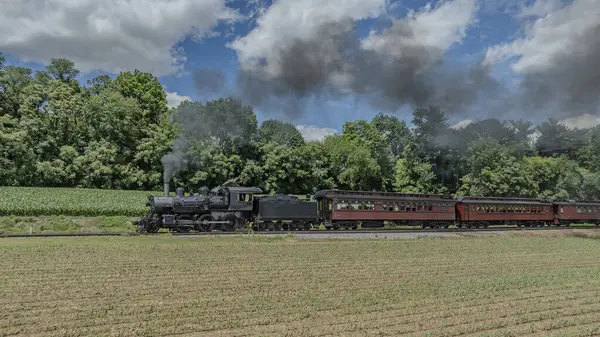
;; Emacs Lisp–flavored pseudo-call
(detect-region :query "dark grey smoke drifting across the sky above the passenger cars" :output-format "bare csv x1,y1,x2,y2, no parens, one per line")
230,20,501,119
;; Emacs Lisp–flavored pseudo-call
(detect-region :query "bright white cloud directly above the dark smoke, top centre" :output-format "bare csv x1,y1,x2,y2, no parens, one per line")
230,0,386,77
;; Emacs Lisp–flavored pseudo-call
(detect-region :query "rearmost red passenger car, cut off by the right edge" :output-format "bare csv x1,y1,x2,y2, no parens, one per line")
554,201,600,226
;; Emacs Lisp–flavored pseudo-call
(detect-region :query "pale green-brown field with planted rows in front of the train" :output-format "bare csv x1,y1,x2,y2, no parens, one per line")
0,232,600,336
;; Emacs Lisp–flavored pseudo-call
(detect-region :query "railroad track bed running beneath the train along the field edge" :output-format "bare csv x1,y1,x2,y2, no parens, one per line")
0,226,600,238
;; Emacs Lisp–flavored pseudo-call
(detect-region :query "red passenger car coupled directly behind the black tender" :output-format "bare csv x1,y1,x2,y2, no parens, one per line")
315,190,456,229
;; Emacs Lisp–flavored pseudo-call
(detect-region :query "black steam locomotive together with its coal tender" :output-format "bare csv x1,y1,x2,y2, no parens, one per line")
136,181,318,233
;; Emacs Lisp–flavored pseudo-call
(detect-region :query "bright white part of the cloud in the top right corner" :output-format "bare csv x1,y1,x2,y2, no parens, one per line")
484,0,600,74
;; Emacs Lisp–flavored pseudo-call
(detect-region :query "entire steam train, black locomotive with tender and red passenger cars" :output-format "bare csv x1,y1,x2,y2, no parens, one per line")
136,179,600,233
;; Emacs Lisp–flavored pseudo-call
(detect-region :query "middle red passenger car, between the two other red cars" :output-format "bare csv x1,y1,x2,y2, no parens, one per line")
456,197,554,228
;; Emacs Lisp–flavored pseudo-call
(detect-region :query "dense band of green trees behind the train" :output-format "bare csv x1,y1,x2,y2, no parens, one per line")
0,53,600,199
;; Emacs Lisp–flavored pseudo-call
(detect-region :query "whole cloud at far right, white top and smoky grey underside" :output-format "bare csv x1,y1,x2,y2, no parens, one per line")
484,0,600,119
